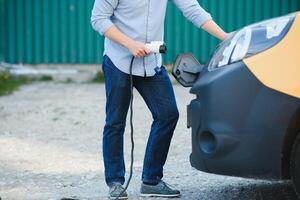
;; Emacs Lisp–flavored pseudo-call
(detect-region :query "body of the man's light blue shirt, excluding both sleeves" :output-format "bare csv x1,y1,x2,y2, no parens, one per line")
104,0,167,76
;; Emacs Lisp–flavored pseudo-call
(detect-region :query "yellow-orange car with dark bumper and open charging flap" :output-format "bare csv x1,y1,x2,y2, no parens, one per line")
172,12,300,195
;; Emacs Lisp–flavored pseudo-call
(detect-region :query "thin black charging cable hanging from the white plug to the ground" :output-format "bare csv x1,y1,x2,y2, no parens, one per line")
116,56,134,200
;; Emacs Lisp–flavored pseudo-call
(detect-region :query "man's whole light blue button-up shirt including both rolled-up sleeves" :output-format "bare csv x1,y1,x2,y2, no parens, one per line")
91,0,211,76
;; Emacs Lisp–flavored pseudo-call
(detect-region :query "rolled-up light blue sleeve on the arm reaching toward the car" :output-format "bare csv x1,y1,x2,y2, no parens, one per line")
173,0,212,27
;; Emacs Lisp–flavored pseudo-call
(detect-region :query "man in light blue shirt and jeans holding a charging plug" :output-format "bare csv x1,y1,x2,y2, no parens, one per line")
91,0,227,199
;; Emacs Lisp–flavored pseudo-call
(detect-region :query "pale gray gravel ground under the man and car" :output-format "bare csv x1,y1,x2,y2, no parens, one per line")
0,83,295,200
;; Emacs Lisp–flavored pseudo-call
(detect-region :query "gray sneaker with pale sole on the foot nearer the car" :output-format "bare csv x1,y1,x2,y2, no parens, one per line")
141,181,180,197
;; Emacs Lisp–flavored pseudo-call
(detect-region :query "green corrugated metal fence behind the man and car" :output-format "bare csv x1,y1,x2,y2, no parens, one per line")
0,0,300,64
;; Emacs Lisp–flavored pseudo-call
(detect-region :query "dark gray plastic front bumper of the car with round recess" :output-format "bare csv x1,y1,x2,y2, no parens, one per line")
188,62,299,179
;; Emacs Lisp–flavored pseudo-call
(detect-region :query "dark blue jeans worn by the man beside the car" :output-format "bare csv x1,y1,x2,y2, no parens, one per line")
102,56,179,185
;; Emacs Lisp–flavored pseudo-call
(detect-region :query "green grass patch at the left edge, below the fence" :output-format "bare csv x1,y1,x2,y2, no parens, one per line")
0,71,53,96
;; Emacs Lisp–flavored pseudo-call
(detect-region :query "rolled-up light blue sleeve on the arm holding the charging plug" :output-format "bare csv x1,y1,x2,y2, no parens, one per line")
91,0,118,35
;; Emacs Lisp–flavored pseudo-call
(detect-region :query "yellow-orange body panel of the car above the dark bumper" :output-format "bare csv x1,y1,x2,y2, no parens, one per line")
244,13,300,98
